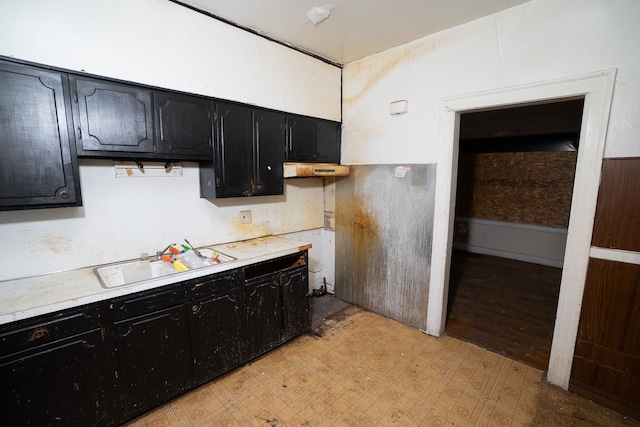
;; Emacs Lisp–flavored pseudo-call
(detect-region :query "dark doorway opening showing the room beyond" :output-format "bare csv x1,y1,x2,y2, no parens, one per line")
445,98,584,370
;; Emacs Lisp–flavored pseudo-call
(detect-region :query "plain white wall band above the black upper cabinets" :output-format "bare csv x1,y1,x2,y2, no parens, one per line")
0,0,341,121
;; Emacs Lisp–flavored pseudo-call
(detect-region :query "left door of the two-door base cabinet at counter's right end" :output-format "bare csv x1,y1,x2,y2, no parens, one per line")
244,275,283,359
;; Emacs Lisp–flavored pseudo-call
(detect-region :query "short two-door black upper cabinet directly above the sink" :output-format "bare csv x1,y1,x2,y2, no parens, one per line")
71,76,211,160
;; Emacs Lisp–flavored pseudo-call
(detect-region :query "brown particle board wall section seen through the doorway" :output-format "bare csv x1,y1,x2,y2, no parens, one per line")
456,151,577,228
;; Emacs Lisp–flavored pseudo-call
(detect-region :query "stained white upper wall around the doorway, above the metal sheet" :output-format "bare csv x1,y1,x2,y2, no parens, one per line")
342,0,640,164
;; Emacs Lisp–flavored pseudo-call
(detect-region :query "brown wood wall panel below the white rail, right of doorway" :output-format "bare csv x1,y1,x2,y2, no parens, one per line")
570,258,640,417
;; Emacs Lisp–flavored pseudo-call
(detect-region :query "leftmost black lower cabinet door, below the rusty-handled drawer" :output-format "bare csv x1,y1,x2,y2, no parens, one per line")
0,329,114,426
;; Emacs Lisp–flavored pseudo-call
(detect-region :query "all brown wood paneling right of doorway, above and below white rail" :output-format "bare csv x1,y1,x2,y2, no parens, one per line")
570,158,640,420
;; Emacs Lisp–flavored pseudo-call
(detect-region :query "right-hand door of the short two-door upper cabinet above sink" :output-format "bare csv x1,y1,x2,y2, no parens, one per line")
153,92,213,160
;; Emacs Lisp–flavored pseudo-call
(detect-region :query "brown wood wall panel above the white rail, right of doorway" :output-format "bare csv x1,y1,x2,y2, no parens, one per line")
592,157,640,252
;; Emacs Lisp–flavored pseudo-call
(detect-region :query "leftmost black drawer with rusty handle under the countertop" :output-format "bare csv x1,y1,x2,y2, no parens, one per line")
0,305,100,357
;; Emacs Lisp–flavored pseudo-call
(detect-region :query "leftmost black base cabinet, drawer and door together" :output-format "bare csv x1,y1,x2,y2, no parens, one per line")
0,306,115,426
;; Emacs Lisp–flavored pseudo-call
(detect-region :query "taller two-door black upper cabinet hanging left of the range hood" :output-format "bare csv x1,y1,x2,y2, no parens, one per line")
200,103,286,198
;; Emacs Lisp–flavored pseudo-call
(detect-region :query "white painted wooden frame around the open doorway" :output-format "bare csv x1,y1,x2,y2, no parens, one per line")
425,69,616,389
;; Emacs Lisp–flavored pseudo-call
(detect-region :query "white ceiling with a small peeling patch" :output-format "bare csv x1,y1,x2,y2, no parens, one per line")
177,0,529,65
